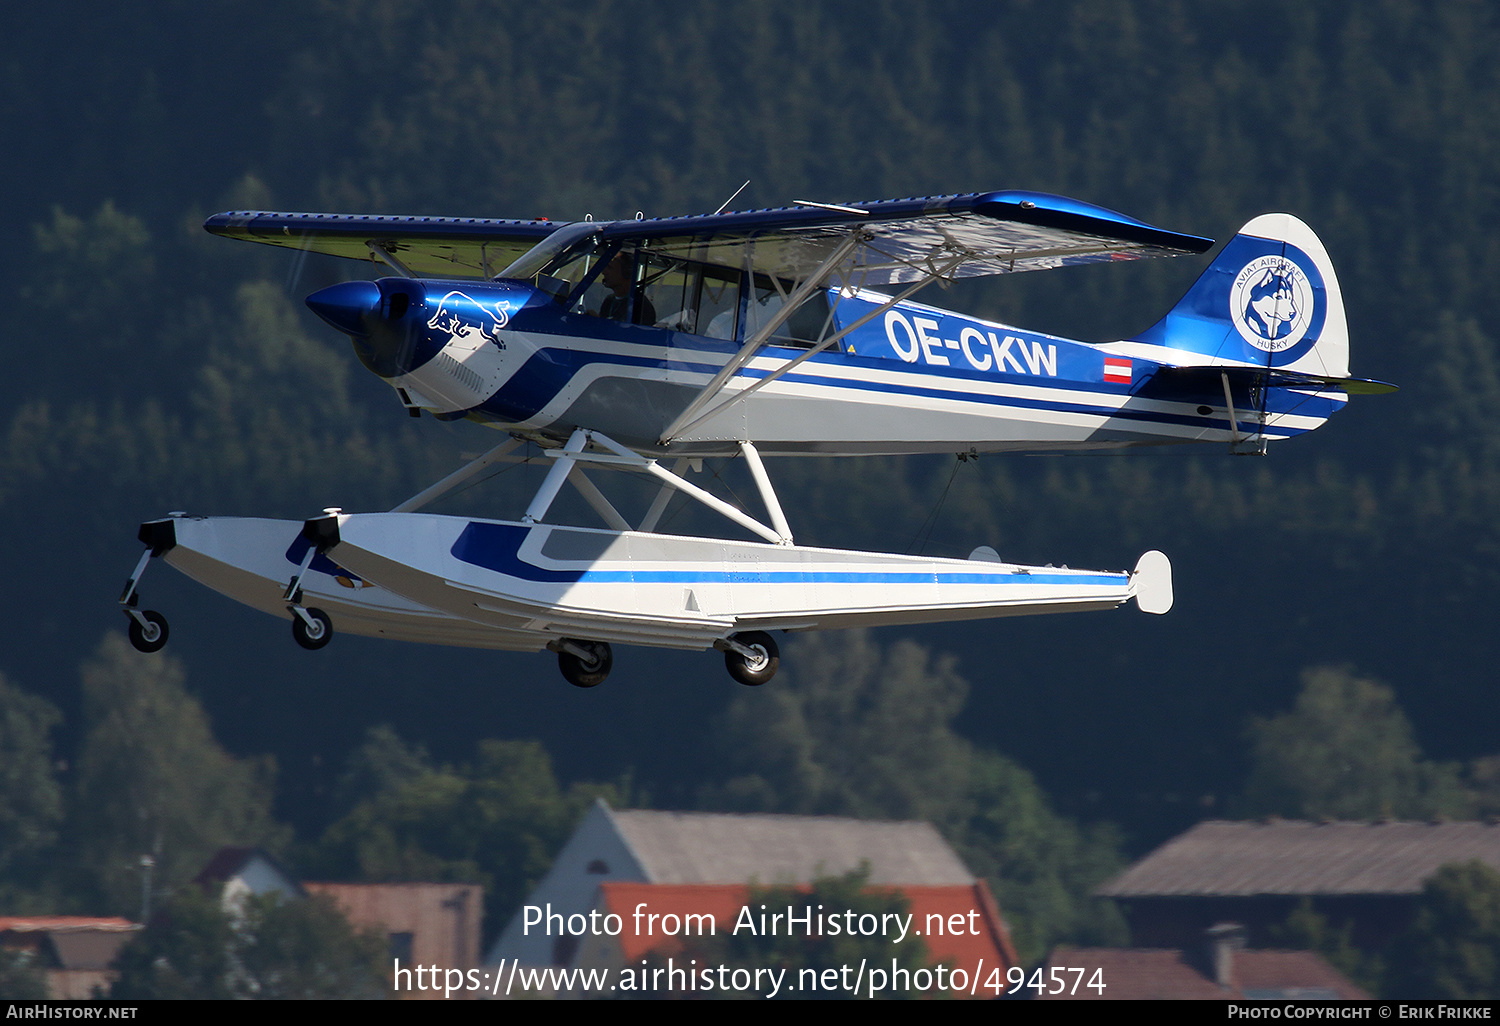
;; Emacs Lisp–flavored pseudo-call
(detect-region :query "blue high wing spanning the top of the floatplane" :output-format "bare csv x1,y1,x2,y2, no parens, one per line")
204,191,1214,287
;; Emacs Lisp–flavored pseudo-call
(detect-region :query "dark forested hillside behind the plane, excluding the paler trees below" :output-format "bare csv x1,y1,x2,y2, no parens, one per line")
0,0,1500,936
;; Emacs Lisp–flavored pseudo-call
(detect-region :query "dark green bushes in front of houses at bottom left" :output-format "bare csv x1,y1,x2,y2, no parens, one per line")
110,888,386,1001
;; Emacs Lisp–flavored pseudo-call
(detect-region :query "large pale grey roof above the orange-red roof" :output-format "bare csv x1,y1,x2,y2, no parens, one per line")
609,809,974,887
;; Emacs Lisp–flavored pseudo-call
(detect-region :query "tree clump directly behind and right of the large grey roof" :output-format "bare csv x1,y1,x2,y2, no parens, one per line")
701,630,1124,963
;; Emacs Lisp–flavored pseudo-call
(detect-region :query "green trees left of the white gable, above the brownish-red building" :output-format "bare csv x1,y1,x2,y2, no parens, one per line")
308,728,623,948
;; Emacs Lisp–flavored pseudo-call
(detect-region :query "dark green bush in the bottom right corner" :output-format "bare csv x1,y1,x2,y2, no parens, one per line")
1385,861,1500,1001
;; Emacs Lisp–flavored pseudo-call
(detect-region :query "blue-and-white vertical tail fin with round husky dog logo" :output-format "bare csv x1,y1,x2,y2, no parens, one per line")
1134,213,1349,378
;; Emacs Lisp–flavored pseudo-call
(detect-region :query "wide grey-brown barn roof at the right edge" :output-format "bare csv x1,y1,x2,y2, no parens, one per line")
1095,821,1500,899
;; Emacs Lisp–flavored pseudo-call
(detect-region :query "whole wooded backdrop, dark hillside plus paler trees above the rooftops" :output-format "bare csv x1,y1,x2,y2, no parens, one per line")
0,0,1500,989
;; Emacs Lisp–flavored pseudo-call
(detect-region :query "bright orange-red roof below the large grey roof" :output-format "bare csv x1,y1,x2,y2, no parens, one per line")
599,881,1016,993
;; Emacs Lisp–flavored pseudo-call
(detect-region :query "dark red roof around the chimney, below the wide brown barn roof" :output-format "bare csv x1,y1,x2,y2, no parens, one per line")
1041,948,1370,1001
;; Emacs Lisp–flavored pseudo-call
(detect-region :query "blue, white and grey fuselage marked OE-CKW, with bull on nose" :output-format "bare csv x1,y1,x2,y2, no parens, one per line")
309,278,1346,455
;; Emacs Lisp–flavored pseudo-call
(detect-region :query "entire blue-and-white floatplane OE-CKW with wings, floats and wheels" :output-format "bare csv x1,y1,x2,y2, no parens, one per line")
120,192,1392,687
